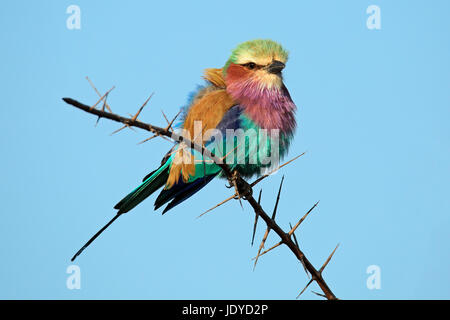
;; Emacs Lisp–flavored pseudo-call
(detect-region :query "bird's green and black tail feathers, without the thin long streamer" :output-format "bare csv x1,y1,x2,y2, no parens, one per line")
114,161,170,214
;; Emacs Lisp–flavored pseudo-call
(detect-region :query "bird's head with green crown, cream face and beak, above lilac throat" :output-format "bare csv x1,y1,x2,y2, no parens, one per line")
223,40,288,93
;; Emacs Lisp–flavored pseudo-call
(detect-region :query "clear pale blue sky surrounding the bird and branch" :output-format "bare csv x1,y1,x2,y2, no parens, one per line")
0,1,450,299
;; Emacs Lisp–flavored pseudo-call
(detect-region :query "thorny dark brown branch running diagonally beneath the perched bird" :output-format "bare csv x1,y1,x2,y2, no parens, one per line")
63,78,339,300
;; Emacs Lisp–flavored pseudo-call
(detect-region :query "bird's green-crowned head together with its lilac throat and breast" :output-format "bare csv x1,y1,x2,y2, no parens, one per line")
222,40,296,135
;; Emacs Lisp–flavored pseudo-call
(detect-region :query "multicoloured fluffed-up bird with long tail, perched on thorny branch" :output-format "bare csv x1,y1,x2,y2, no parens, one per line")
71,39,297,261
